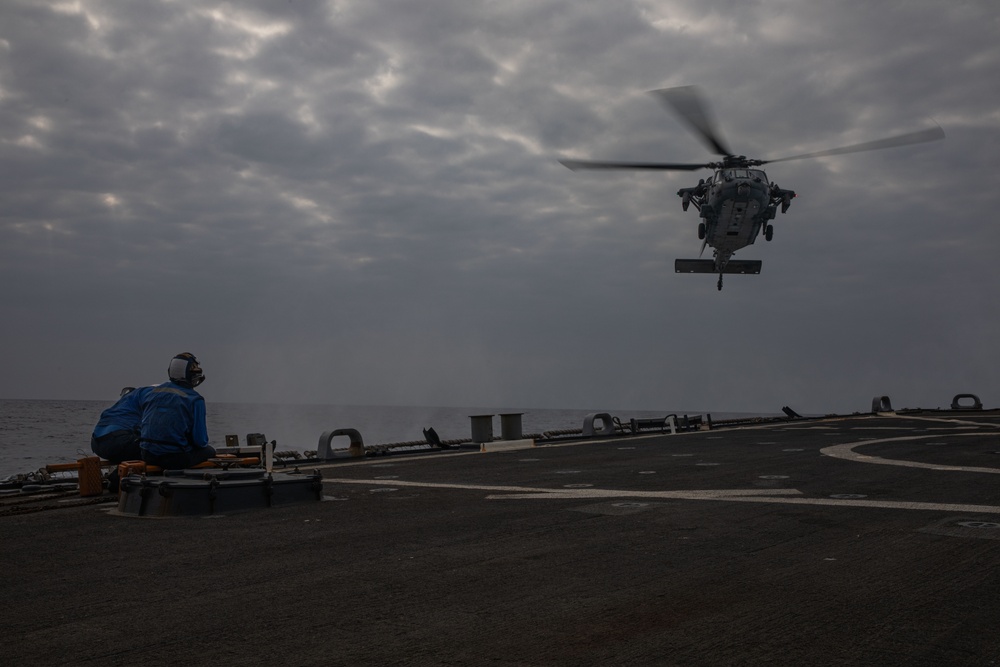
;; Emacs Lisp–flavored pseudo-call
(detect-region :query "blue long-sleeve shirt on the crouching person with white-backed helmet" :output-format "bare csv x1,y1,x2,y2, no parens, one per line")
139,382,208,455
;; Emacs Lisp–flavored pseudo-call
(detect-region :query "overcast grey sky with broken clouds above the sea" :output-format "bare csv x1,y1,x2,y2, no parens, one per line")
0,0,1000,413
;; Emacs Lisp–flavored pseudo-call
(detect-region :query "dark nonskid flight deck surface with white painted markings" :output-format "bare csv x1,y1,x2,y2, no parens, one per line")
0,412,1000,665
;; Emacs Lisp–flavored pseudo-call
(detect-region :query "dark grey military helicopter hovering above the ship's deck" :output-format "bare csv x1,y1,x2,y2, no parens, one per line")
560,86,944,290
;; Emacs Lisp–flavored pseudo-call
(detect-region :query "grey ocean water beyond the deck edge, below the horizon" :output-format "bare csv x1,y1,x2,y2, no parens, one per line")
0,399,764,479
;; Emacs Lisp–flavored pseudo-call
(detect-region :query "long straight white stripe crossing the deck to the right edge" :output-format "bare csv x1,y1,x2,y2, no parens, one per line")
323,478,1000,514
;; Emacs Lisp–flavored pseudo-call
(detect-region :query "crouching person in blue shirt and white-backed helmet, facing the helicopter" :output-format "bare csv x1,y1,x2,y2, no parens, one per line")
139,352,215,470
